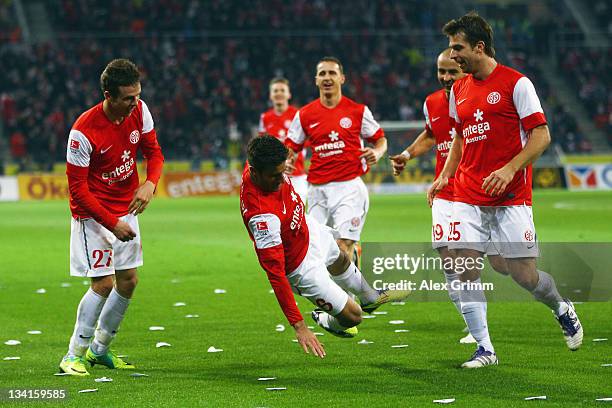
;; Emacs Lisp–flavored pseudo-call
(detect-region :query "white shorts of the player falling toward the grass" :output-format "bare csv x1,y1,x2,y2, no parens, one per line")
287,216,348,316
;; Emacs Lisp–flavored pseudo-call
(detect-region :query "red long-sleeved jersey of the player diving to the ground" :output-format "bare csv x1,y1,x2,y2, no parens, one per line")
240,167,309,324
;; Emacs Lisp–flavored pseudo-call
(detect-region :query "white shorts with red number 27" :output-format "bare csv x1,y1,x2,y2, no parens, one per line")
70,214,142,278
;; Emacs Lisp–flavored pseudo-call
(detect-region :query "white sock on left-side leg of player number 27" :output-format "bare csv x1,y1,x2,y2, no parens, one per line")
67,288,106,357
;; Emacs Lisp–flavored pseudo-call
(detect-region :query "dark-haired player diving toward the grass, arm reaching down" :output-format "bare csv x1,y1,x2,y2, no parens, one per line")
240,136,408,358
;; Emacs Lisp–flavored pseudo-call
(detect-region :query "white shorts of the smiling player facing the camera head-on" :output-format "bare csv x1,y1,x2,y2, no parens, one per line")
308,177,370,241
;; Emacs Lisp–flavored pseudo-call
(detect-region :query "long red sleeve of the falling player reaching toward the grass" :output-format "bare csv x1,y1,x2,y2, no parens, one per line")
255,245,304,325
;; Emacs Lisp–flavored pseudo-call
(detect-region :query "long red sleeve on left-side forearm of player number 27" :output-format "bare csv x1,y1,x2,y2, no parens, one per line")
66,163,119,231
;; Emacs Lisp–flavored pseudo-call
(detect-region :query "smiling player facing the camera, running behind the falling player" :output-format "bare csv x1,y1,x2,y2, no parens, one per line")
286,57,387,264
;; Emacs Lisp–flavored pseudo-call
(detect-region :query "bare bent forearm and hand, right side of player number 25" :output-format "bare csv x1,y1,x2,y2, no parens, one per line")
482,125,550,196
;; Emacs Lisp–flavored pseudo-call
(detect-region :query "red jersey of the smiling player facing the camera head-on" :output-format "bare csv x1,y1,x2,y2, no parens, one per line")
286,96,384,184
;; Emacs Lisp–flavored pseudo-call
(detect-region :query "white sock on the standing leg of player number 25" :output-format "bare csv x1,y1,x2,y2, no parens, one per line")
460,278,495,353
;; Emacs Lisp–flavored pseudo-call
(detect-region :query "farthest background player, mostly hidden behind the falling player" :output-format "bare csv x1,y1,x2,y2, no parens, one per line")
258,78,308,202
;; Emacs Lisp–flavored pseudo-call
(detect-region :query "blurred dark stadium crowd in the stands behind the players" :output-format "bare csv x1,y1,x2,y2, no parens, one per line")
0,0,610,169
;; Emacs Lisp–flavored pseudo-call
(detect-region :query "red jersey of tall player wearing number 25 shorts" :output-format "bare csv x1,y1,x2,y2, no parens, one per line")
449,64,546,206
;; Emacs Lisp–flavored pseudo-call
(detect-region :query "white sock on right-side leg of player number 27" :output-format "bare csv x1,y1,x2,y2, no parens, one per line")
91,288,130,355
